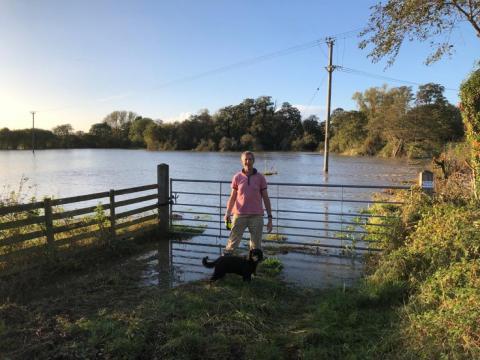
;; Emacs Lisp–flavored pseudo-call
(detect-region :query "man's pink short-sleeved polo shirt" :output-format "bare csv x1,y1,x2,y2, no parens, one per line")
232,169,267,215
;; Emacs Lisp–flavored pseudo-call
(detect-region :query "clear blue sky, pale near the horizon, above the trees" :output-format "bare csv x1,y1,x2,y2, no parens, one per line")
0,0,480,131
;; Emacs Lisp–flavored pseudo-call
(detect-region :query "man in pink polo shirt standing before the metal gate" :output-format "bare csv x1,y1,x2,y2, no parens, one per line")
224,151,272,255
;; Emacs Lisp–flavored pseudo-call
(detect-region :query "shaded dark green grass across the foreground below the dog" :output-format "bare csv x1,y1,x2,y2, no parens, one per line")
0,240,402,359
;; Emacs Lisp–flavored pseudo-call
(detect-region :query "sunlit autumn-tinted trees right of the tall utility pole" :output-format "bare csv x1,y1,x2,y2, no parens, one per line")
330,83,464,158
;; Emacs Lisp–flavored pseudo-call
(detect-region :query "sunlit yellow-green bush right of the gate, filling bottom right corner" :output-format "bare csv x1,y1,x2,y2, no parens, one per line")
366,202,480,359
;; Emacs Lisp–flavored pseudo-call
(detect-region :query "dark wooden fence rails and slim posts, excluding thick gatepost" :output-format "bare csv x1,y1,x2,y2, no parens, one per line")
0,184,159,259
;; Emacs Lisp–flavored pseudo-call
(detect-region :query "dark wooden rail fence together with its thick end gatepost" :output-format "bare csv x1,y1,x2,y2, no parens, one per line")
0,164,169,262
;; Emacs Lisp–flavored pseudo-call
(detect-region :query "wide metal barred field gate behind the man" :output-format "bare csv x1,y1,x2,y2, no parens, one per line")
170,178,410,254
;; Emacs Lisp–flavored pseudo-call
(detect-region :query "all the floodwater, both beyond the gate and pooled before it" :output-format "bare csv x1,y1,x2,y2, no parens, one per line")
0,149,423,287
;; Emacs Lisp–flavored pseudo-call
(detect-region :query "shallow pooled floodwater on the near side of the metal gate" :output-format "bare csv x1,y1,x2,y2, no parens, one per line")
136,239,363,288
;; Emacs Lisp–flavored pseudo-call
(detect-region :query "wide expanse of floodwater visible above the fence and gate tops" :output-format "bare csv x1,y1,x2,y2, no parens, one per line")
0,149,421,198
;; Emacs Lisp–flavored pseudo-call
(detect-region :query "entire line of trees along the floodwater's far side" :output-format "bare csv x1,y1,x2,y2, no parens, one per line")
0,83,463,157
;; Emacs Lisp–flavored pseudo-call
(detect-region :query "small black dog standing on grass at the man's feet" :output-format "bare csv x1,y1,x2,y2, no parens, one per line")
202,249,263,281
